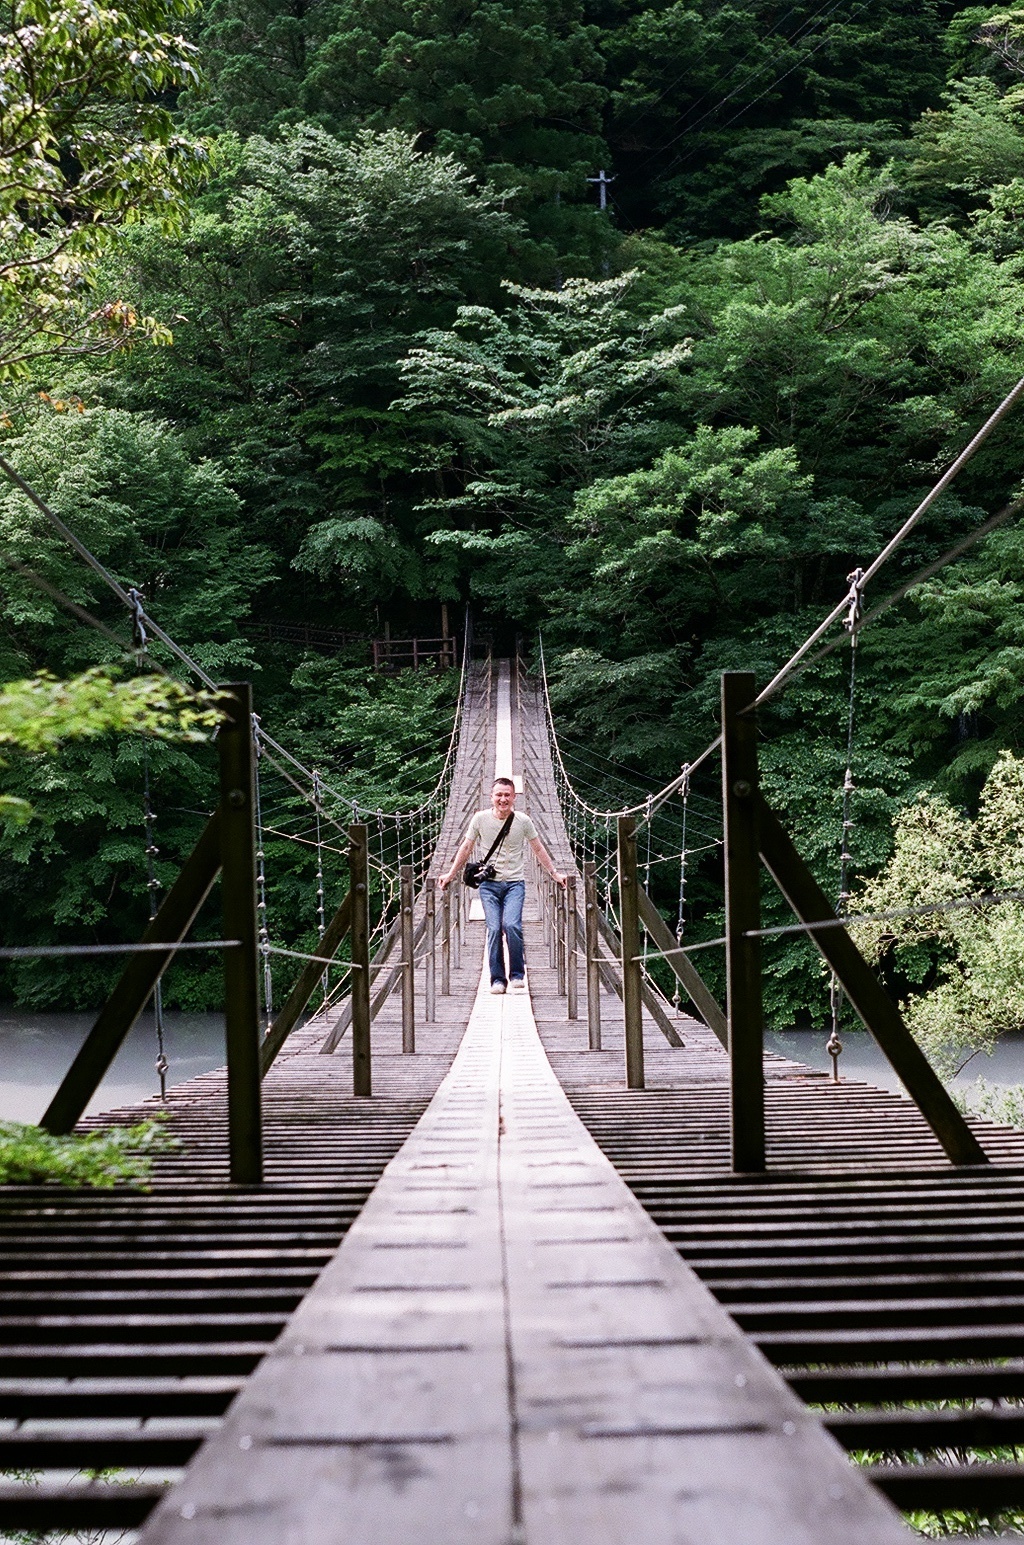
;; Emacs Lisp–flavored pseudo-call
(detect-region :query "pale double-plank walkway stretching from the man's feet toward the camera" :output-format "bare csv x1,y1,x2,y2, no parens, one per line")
142,964,908,1545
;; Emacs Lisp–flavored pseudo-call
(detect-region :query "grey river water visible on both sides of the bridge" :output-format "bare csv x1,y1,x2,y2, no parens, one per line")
0,1007,1024,1122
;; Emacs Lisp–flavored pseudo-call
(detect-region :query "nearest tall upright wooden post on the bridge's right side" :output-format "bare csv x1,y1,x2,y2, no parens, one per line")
721,671,765,1171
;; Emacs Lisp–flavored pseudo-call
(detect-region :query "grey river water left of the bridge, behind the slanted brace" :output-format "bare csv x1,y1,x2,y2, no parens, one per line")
0,1006,224,1122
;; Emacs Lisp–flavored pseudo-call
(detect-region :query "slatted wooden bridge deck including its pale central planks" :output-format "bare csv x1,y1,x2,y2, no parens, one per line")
0,661,1024,1545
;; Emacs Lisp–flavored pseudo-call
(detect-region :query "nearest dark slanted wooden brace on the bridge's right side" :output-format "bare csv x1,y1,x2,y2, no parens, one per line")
758,797,987,1165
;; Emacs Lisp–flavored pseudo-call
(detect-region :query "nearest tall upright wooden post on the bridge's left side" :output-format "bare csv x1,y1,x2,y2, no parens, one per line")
216,681,263,1185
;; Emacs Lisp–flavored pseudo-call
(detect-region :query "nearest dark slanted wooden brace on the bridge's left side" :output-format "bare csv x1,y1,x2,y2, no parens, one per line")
39,814,222,1134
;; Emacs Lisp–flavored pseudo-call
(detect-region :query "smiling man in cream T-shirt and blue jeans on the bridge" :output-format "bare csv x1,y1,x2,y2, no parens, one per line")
437,777,565,993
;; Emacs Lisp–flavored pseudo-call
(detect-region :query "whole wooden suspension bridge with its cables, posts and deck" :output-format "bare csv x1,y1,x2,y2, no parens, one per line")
0,383,1024,1545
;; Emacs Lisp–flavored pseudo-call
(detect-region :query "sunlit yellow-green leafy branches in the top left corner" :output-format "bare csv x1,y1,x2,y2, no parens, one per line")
0,0,204,379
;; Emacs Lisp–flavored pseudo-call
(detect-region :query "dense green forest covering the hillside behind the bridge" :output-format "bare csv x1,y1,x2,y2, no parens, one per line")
0,0,1024,1066
